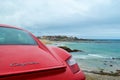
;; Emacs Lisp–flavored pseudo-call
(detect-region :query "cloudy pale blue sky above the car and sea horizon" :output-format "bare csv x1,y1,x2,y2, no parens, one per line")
0,0,120,39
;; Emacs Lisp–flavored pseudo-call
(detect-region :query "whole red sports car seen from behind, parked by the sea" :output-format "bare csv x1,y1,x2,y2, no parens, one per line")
0,24,85,80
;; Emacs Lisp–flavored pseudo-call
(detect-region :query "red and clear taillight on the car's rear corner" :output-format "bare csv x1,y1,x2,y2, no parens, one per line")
67,57,80,73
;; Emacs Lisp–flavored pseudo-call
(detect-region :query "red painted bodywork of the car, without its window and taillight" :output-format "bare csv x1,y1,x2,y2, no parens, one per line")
0,24,85,80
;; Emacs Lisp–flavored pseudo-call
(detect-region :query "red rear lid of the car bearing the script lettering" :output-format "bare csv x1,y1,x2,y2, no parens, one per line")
0,45,65,76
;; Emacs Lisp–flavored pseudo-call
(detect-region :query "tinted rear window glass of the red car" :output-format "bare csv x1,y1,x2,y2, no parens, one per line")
0,27,36,45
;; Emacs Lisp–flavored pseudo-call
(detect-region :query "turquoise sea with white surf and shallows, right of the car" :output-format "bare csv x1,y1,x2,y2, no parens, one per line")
64,40,120,72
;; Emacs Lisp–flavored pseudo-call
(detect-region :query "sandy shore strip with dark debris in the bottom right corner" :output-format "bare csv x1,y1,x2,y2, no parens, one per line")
83,67,120,80
